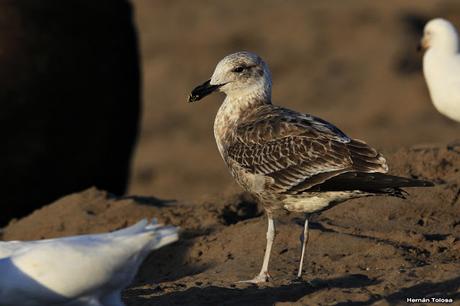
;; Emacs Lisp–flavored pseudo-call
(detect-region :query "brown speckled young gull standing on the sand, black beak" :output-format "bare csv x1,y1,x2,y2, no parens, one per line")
189,52,432,283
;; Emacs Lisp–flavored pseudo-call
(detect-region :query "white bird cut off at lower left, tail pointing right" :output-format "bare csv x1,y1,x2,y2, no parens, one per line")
0,220,178,306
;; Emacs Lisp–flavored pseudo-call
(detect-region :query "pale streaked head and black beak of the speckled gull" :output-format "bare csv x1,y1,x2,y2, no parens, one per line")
188,51,272,102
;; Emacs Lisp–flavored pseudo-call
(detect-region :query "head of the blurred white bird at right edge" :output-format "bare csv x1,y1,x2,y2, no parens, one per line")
420,18,458,53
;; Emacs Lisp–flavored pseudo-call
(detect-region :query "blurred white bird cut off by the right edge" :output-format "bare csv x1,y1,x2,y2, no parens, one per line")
421,18,460,122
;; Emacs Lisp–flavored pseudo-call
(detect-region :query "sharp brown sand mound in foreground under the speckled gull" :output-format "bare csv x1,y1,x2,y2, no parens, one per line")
4,146,460,305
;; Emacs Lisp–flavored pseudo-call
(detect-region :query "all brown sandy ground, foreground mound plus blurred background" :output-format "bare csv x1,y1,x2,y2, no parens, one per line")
3,0,460,306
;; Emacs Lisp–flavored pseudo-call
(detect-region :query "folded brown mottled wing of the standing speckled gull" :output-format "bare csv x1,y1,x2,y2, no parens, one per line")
227,106,388,193
